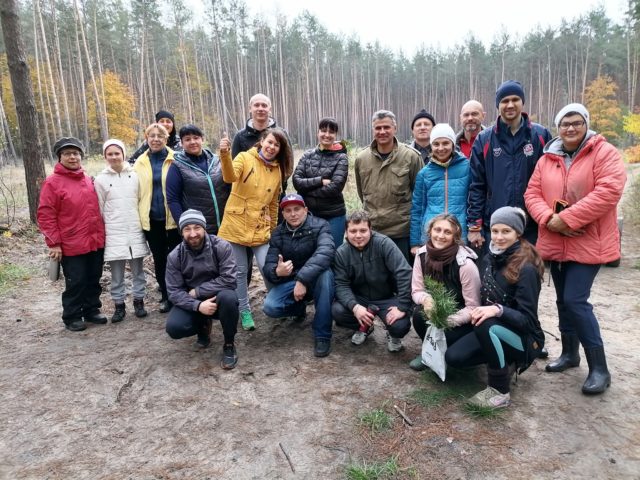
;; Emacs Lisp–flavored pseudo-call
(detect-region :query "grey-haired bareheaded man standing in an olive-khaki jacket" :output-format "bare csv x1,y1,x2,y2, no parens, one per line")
355,110,424,263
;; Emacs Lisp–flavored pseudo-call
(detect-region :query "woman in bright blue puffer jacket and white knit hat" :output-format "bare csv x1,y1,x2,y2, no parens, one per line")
410,123,471,255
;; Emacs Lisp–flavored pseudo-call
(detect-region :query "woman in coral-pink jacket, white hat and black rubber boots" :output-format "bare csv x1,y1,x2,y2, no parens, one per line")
524,103,626,394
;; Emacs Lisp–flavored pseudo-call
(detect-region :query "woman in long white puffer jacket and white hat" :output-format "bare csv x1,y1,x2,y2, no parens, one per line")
95,139,149,323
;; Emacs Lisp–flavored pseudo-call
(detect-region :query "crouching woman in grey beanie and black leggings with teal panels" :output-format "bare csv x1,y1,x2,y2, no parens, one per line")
447,207,544,408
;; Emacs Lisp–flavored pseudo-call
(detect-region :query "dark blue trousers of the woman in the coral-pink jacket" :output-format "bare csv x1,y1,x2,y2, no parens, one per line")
551,262,602,348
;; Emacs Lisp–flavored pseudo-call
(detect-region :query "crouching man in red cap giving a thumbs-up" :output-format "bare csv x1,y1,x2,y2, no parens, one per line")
263,193,335,357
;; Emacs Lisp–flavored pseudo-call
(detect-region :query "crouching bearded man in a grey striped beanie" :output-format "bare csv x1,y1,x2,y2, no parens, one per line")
166,209,238,370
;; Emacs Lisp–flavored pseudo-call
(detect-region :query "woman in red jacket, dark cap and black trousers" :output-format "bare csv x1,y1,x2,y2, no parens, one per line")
38,137,107,332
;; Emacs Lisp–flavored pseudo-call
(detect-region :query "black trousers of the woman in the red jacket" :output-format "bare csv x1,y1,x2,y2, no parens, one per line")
60,248,104,324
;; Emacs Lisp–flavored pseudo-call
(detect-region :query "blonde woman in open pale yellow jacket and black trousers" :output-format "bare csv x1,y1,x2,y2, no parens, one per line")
133,123,182,313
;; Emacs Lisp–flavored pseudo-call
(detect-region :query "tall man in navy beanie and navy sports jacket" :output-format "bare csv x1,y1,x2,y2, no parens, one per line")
467,80,551,253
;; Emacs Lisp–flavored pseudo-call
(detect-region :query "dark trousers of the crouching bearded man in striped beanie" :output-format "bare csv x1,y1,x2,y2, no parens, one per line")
166,290,239,343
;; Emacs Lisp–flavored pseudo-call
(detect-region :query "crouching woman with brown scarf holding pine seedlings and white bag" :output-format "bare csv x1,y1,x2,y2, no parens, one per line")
409,213,482,370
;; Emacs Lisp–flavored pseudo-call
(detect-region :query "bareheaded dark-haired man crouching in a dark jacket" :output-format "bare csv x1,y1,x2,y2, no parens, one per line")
332,211,412,352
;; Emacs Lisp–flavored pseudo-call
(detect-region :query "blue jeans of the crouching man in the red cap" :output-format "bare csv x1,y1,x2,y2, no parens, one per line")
262,269,335,338
